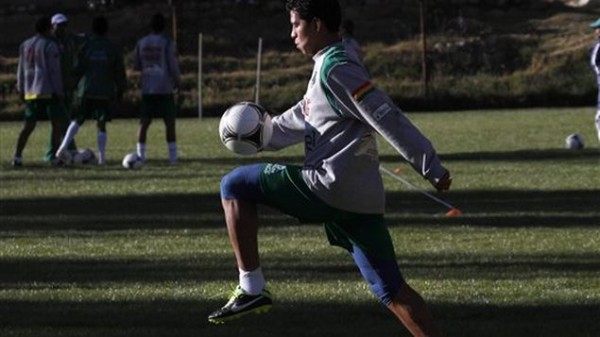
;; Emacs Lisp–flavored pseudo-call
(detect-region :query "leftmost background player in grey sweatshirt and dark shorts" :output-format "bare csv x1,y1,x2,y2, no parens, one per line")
12,16,64,167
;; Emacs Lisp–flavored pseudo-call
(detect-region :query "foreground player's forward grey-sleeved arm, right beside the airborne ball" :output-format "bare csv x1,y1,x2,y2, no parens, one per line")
264,101,305,151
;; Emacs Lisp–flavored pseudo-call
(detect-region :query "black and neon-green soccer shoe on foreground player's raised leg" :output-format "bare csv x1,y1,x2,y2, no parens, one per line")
208,286,273,324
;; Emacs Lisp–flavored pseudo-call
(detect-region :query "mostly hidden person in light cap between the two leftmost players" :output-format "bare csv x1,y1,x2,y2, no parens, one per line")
44,13,81,161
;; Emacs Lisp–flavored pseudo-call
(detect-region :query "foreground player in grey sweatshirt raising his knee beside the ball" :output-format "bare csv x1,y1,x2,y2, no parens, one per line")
208,0,451,337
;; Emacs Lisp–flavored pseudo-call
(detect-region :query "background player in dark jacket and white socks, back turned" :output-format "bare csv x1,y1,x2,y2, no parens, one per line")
56,16,126,166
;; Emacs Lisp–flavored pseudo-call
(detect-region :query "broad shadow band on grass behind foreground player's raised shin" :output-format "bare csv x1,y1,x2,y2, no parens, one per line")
0,190,600,231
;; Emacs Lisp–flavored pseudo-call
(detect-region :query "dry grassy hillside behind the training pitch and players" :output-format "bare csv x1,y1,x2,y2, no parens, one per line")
0,0,600,119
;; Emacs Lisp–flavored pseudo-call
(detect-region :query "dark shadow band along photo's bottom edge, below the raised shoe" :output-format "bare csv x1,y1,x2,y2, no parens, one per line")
0,294,600,337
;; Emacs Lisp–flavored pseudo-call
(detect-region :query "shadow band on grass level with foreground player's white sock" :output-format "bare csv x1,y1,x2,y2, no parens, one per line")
0,251,600,284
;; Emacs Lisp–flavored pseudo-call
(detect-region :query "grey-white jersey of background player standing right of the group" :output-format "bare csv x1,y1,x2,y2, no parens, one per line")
134,34,181,95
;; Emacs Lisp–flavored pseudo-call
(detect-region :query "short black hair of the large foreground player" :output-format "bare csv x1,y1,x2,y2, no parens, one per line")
285,0,342,33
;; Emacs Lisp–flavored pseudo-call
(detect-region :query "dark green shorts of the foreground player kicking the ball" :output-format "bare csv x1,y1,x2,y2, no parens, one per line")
260,164,396,261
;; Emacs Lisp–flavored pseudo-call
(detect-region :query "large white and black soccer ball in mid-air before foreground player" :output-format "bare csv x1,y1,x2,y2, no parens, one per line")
219,102,273,155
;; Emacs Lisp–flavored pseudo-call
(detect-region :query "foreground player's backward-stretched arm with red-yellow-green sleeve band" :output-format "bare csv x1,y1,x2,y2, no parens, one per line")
326,62,446,185
